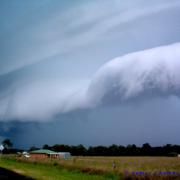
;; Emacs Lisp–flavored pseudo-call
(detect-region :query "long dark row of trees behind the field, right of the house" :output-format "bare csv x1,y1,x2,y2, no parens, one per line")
35,143,180,156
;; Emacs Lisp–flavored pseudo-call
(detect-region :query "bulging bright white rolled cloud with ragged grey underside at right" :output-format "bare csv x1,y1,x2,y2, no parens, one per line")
88,43,180,104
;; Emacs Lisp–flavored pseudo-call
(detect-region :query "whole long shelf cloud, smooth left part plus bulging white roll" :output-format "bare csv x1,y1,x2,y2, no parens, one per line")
0,43,180,121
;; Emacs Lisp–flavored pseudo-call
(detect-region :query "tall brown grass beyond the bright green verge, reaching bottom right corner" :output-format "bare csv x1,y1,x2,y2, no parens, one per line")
0,156,180,180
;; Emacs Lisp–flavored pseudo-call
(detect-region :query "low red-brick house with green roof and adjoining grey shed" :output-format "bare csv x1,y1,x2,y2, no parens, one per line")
30,149,71,158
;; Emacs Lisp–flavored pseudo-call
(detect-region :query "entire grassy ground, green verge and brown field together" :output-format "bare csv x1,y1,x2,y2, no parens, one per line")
0,156,180,180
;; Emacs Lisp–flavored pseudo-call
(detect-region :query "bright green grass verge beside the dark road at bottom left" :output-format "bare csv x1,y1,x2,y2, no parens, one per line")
0,156,118,180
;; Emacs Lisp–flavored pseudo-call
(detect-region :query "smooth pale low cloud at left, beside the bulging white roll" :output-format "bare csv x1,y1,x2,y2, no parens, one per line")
0,79,88,121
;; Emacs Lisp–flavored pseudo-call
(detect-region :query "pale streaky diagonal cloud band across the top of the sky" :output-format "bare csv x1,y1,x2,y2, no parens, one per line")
0,1,180,74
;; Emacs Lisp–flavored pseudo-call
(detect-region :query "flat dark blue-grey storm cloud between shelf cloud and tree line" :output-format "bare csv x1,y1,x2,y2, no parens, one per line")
6,96,180,148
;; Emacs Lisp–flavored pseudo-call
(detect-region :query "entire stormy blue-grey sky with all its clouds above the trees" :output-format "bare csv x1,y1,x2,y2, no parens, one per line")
0,0,180,148
